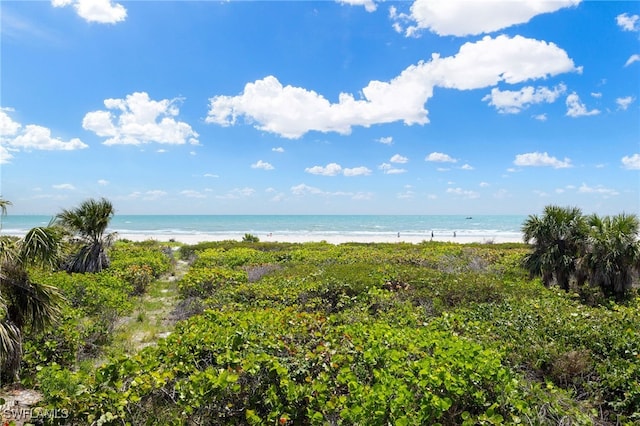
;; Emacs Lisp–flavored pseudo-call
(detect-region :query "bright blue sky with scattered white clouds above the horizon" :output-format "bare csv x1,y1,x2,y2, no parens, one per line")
0,0,640,214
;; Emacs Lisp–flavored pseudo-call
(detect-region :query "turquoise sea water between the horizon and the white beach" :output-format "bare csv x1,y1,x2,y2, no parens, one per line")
1,215,526,239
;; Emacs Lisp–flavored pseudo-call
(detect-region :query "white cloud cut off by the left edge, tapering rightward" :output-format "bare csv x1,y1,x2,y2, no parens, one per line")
0,108,89,164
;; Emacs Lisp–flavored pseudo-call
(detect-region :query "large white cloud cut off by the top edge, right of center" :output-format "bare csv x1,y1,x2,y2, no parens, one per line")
391,0,580,36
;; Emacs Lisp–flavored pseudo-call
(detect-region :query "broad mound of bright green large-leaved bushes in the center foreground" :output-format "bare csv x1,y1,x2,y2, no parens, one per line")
36,309,592,425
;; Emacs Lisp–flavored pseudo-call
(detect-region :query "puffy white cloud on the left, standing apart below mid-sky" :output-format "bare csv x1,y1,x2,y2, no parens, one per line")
82,92,198,145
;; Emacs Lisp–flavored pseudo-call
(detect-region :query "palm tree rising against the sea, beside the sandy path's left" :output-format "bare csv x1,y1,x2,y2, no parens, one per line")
56,198,115,273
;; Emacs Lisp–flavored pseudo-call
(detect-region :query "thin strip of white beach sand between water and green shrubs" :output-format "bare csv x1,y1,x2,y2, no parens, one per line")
118,234,522,244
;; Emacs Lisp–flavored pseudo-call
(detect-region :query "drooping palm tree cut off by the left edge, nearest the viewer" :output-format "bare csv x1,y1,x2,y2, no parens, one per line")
0,199,62,380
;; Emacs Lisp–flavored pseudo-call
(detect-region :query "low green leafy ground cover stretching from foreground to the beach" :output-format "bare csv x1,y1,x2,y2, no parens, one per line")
11,241,640,425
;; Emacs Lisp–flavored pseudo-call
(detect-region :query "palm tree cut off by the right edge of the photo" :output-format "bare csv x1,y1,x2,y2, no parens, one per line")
581,213,640,297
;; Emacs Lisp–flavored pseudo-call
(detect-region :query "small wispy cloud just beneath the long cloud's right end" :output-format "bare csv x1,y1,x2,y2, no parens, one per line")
482,84,567,114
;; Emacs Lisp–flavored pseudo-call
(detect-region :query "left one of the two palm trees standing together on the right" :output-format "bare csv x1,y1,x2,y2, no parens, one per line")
522,206,587,291
